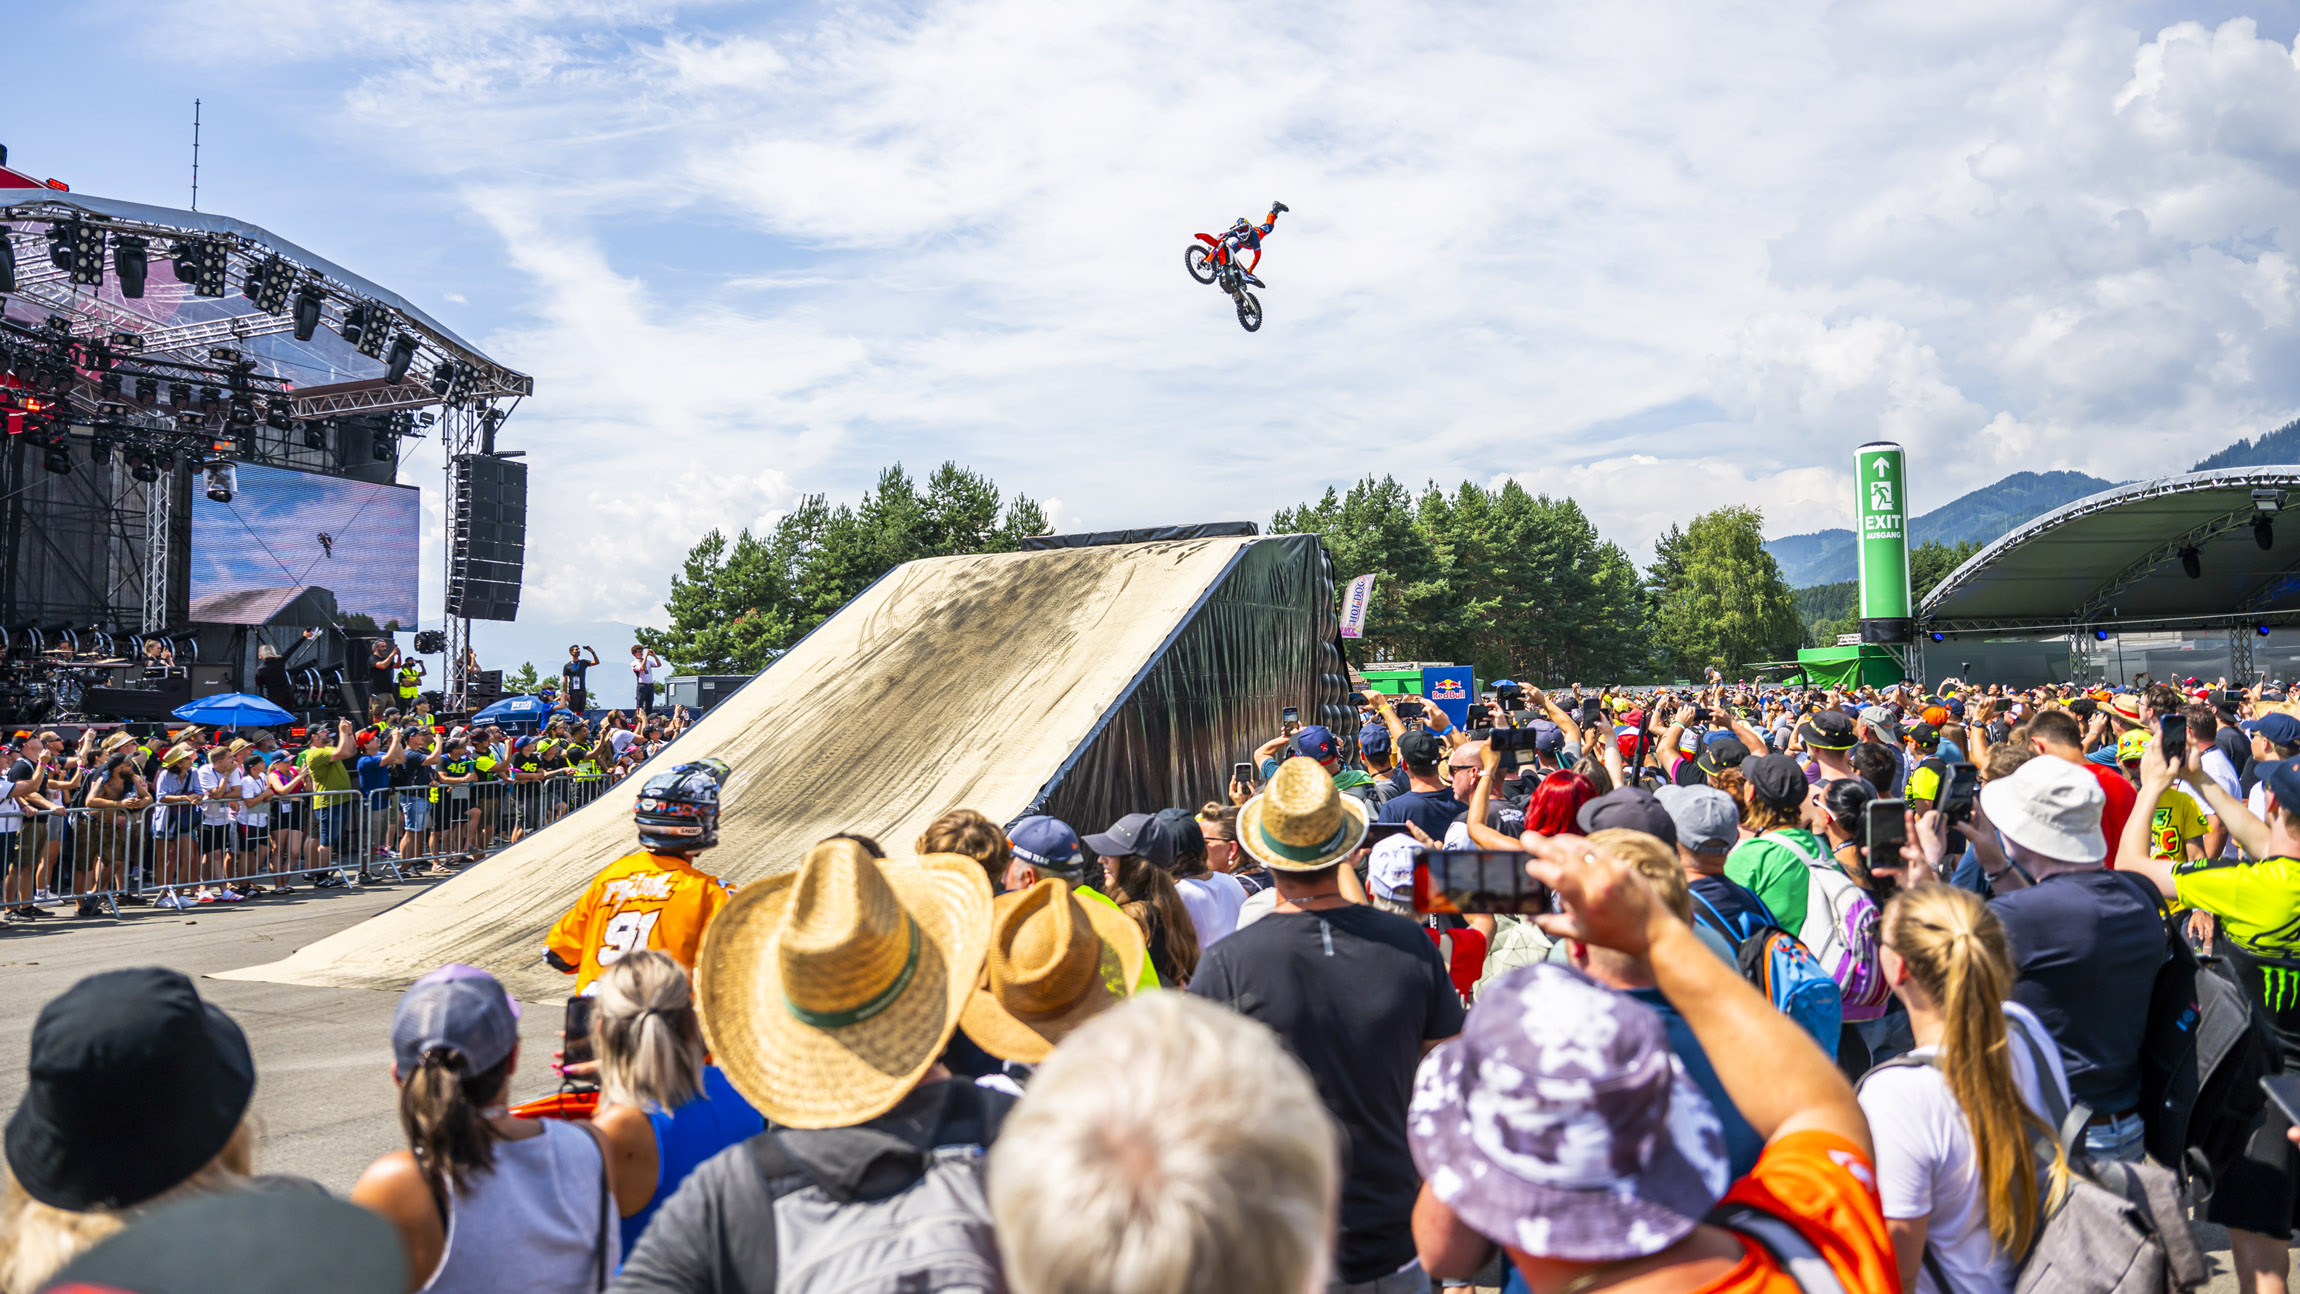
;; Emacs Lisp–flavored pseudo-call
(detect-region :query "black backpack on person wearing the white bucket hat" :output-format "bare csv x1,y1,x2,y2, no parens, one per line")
2134,880,2284,1202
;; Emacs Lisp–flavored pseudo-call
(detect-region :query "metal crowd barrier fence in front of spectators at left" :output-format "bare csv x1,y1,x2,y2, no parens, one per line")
0,775,614,917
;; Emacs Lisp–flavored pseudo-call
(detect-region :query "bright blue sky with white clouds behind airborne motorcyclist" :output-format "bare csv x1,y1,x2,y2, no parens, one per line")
17,0,2300,703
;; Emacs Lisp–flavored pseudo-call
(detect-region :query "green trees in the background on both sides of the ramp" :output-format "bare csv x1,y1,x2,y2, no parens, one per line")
637,462,1971,683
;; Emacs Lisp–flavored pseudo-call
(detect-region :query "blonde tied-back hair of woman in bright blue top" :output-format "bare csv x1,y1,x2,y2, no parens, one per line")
591,949,704,1112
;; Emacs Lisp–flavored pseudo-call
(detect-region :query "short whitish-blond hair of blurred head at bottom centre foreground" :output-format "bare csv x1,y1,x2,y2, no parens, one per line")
989,993,1341,1294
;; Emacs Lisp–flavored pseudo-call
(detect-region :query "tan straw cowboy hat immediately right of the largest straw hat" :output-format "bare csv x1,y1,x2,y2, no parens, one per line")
959,878,1143,1064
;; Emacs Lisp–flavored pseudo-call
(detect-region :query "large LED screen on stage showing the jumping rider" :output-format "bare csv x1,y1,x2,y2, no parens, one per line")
191,464,421,627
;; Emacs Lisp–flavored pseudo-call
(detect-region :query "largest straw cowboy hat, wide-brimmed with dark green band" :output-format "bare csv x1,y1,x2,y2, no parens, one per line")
695,839,991,1129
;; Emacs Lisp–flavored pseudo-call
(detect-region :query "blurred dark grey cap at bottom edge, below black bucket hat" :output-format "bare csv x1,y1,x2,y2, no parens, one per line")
41,1185,407,1294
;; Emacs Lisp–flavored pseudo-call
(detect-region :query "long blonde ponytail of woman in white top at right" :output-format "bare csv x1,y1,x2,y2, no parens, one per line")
1881,883,2065,1262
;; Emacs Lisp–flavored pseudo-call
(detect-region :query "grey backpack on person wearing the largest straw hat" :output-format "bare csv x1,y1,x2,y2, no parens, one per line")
745,1083,1010,1294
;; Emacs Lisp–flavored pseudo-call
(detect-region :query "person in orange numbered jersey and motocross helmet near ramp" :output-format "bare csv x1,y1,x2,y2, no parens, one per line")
543,758,734,998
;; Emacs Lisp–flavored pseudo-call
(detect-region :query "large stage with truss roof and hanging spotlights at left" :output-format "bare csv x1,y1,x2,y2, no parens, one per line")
0,149,534,726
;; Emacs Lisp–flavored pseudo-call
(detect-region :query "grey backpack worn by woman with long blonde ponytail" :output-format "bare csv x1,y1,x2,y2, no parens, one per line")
1861,1018,2206,1294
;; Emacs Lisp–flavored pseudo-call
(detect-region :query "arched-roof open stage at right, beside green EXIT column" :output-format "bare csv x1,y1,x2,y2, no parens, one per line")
1916,464,2300,685
